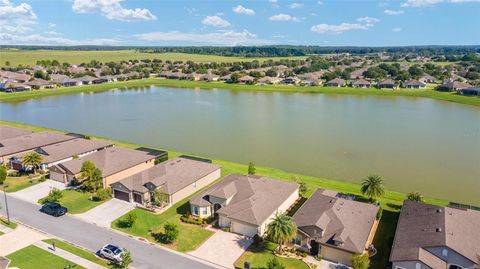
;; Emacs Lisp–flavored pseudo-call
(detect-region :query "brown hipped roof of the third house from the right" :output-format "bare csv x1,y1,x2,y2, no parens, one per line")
190,174,299,225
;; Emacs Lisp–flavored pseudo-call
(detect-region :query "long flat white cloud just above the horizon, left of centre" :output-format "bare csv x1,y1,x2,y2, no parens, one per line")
135,30,272,46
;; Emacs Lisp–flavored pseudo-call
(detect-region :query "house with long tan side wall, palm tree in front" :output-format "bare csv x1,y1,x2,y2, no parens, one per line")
49,147,156,187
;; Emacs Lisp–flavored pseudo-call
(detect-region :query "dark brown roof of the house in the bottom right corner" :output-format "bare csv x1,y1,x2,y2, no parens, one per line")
390,200,480,268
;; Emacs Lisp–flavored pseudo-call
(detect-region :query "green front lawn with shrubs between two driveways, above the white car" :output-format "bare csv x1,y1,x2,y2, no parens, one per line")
112,198,213,252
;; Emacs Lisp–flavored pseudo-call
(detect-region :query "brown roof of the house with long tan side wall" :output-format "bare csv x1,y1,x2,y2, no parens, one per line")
57,147,155,177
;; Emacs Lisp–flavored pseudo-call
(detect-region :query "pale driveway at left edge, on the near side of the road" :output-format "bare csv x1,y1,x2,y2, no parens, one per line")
0,225,47,256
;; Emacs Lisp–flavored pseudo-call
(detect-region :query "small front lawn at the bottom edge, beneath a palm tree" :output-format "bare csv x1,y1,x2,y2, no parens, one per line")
235,242,309,269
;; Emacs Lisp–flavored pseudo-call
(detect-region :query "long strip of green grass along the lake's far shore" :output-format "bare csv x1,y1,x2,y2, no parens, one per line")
0,78,480,107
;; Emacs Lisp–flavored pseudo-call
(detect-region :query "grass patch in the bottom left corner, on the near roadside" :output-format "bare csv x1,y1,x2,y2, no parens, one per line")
7,246,83,269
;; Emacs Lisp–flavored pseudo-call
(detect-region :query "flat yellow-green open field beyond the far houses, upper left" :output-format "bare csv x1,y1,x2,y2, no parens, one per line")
0,49,307,67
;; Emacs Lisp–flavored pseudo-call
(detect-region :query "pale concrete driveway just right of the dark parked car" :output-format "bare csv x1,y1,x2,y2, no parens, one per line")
75,198,135,228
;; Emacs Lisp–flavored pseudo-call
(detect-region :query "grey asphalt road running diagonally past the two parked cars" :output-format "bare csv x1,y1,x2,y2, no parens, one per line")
0,192,219,269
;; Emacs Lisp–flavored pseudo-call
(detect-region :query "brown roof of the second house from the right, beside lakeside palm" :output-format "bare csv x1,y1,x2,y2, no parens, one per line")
293,189,378,253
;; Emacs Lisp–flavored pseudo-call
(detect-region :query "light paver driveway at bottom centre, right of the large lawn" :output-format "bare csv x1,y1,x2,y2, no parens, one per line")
189,230,253,268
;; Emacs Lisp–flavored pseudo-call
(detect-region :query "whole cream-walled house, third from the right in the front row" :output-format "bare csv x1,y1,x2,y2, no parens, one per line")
190,174,299,236
